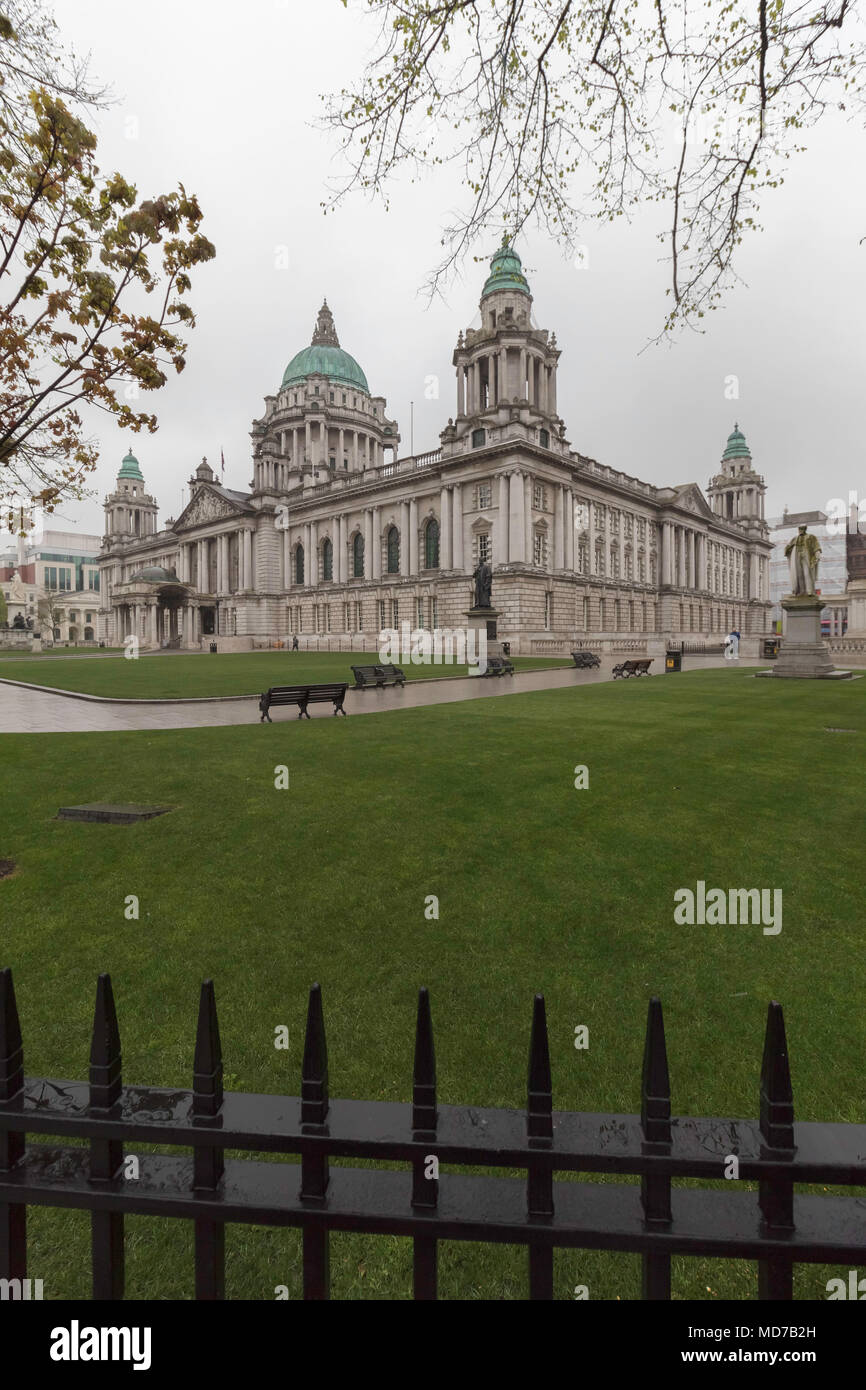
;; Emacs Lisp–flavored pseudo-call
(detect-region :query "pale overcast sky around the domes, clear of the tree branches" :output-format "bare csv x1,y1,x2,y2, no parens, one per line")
6,0,866,534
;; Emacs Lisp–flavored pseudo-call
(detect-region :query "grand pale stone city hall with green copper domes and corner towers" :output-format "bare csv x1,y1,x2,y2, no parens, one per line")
99,246,771,653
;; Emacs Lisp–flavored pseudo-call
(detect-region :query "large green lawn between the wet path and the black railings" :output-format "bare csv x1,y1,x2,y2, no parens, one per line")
0,667,866,1300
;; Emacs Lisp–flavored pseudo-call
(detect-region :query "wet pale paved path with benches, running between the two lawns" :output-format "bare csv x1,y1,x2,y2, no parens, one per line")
0,655,756,734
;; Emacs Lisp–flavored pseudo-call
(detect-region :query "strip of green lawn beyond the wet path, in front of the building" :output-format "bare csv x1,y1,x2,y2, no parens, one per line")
0,652,571,699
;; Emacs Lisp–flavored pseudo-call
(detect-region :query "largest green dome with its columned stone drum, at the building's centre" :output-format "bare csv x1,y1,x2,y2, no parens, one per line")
252,299,400,498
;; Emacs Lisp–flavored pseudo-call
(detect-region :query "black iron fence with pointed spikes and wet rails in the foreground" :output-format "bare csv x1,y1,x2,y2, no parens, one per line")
0,970,866,1300
